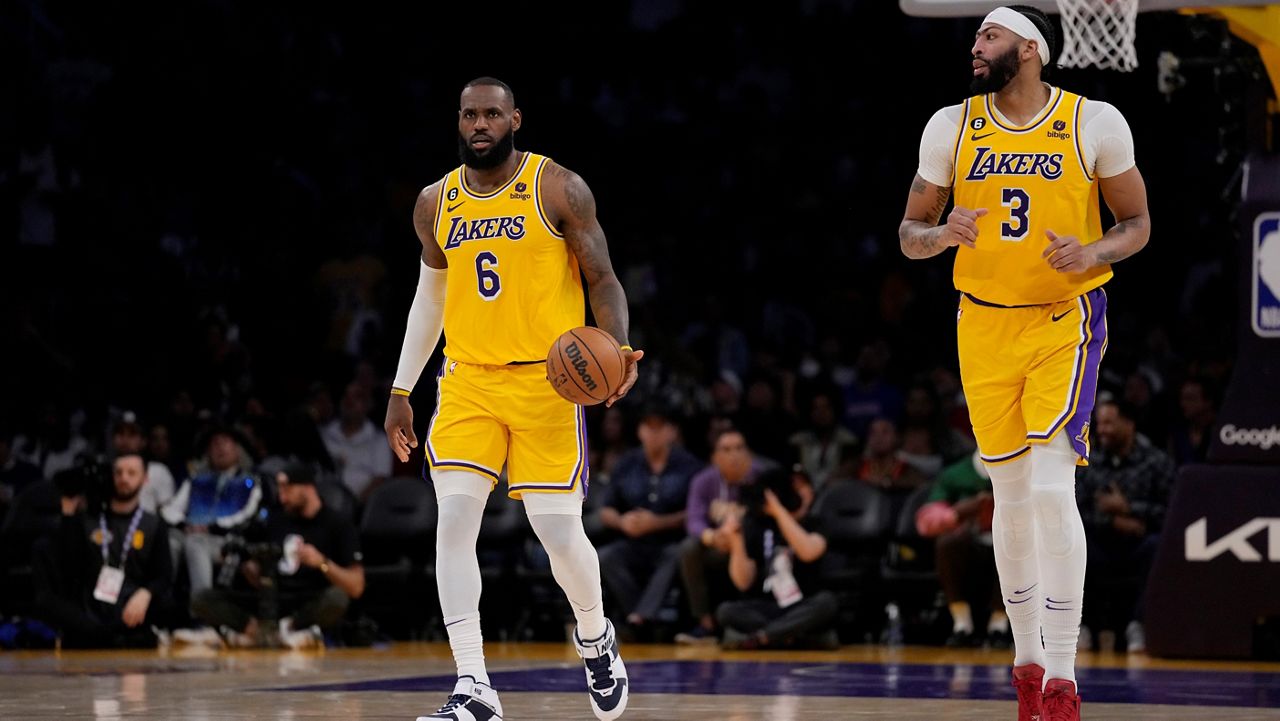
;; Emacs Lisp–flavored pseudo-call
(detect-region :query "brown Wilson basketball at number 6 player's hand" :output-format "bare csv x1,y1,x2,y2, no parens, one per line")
547,325,626,406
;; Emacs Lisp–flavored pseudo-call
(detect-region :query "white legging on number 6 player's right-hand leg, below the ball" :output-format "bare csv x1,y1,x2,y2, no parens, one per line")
529,514,608,640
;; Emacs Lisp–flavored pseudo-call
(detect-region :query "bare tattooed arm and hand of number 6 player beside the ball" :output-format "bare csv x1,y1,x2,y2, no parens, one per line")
543,163,644,405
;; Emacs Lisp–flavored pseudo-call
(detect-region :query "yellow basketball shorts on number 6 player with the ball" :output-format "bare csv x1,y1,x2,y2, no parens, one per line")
426,359,590,499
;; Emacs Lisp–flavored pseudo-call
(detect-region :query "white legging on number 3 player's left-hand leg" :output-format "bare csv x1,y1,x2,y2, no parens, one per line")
987,455,1044,666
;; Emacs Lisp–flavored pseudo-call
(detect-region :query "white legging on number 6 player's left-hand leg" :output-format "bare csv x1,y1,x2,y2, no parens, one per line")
435,494,489,684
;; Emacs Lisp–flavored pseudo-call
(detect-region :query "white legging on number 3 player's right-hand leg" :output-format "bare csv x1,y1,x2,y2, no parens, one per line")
1030,434,1087,683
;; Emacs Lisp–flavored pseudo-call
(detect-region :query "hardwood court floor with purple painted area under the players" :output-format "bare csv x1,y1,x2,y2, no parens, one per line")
0,644,1280,721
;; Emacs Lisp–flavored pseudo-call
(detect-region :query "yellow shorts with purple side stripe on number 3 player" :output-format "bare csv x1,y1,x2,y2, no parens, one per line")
956,288,1107,465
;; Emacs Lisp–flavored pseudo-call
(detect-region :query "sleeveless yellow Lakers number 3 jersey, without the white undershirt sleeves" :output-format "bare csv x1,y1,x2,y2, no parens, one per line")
952,87,1111,306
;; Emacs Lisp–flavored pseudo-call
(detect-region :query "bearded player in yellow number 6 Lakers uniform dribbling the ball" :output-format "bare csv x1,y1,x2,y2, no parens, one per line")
385,78,644,721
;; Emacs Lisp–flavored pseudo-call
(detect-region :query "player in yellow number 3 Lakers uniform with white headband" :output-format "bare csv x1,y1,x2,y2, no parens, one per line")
899,5,1149,721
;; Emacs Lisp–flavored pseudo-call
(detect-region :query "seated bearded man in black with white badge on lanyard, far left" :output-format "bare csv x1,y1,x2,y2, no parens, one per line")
35,453,173,648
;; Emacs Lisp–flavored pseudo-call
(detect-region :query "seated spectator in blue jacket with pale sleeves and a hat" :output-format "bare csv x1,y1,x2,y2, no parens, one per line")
161,428,262,597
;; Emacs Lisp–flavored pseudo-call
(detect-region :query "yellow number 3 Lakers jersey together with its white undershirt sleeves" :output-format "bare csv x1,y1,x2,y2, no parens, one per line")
919,87,1134,306
